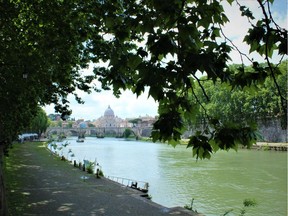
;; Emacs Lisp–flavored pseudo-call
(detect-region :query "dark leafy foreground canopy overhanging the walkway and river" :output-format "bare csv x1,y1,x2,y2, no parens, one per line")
0,0,287,157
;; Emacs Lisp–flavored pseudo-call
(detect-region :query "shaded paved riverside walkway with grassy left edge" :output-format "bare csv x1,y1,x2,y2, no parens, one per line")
4,142,198,216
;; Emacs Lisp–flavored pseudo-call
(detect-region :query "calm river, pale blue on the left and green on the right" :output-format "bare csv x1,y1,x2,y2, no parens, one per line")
53,137,287,216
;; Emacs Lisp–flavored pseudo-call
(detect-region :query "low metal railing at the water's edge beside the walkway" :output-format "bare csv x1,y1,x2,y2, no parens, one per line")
106,176,149,192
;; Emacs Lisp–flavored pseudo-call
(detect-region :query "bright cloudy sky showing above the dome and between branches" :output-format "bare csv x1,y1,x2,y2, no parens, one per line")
44,0,287,120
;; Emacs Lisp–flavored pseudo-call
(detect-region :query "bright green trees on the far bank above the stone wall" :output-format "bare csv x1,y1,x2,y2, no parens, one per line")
188,60,288,126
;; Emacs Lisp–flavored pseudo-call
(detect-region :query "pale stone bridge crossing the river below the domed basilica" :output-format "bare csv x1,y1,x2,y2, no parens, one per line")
45,127,152,137
